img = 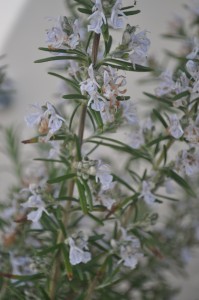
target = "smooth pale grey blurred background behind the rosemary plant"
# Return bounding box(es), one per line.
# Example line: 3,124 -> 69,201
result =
0,0 -> 199,300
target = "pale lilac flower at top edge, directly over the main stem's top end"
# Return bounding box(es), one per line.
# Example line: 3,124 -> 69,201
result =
88,0 -> 106,34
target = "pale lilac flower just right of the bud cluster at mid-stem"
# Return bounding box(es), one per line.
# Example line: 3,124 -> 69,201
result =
95,160 -> 113,190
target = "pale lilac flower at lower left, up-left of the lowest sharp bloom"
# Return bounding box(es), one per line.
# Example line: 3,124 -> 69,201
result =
21,184 -> 48,222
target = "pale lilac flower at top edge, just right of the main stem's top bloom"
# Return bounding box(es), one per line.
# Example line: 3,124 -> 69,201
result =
111,0 -> 126,29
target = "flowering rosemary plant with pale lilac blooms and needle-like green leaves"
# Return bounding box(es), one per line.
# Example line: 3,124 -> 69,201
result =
0,0 -> 199,300
